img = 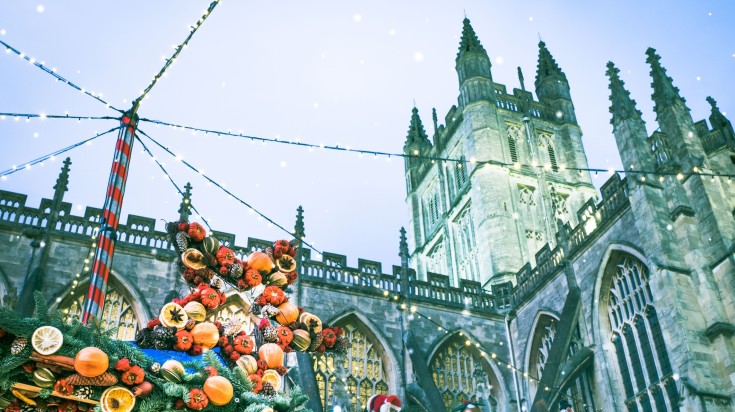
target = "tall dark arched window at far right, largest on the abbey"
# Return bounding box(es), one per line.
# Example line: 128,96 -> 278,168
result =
604,255 -> 679,412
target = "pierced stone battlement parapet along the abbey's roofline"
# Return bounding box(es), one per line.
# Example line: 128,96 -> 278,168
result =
0,174 -> 629,314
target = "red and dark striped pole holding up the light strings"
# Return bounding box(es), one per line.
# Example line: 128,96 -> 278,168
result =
82,112 -> 138,325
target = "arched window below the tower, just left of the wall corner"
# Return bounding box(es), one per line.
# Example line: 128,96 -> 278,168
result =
429,334 -> 501,410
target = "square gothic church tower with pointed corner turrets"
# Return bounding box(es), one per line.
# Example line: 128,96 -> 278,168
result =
404,18 -> 596,287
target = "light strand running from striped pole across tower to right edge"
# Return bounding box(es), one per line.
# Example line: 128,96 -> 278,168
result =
140,118 -> 735,180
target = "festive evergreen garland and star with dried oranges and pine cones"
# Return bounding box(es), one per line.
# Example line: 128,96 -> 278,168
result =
0,217 -> 350,412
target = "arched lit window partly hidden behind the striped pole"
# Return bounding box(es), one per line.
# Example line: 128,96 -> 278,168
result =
59,283 -> 138,340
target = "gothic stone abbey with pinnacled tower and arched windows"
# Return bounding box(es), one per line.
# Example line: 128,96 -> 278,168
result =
0,19 -> 735,412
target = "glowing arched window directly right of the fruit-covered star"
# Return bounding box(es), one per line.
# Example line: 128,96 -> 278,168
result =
312,317 -> 390,411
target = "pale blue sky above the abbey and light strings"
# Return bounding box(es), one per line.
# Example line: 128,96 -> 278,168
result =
0,0 -> 735,271
